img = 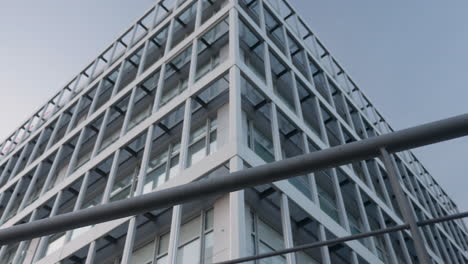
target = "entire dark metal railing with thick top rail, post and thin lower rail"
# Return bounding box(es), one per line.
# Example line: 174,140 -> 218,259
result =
0,114 -> 468,263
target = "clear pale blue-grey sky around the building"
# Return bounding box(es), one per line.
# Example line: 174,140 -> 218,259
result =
0,0 -> 468,210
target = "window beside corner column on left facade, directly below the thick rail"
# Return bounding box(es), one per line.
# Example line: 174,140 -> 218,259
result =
176,209 -> 214,264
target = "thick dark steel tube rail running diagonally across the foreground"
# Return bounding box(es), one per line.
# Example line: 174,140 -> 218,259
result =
0,114 -> 468,245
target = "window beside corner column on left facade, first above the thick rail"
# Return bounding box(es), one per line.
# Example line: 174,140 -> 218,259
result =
187,117 -> 217,167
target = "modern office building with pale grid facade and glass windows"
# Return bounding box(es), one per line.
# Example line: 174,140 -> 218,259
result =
0,0 -> 468,264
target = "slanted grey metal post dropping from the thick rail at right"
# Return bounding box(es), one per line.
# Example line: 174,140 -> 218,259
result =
380,148 -> 431,263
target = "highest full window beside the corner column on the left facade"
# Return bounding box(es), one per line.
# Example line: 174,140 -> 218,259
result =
196,18 -> 229,80
